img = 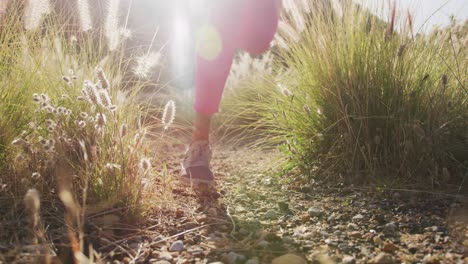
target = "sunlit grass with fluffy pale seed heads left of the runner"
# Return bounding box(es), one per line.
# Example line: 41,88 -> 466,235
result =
0,1 -> 168,250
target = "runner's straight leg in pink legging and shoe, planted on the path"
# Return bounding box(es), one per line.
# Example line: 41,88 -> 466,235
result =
181,0 -> 244,185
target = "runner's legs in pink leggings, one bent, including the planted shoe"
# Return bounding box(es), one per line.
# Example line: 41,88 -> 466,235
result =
182,0 -> 281,184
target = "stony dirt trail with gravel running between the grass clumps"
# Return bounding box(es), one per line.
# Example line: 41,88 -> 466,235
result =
0,146 -> 468,264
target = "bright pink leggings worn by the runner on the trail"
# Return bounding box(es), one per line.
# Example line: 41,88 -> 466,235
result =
194,0 -> 281,115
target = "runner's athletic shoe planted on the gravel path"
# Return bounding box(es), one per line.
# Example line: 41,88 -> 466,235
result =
180,140 -> 214,185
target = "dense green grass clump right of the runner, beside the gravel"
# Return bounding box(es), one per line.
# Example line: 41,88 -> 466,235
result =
225,1 -> 468,188
